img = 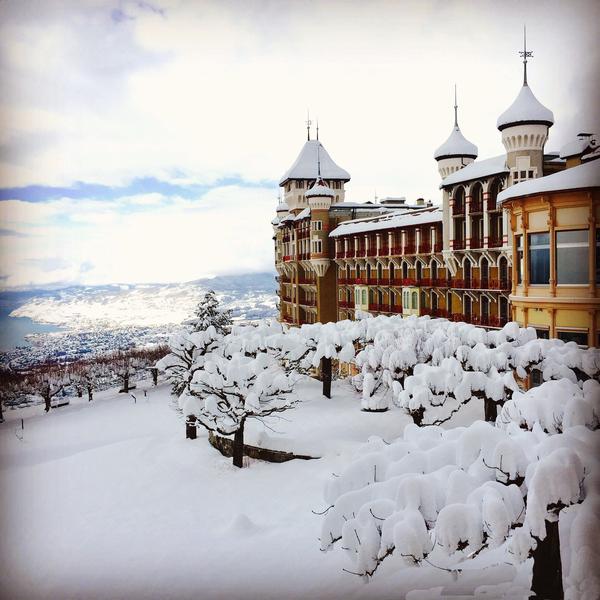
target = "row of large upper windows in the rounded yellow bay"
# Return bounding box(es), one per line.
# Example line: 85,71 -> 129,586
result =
515,229 -> 600,285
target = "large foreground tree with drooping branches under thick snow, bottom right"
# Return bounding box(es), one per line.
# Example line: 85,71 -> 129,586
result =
321,373 -> 600,598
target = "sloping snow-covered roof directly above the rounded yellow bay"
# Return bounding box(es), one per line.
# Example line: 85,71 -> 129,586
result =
498,160 -> 600,204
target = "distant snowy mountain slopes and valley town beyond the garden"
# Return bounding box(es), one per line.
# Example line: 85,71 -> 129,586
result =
0,273 -> 277,368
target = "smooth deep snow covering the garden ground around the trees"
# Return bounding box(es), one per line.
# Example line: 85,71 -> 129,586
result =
0,379 -> 530,600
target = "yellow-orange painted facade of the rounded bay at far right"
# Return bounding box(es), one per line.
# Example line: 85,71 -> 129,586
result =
504,188 -> 600,346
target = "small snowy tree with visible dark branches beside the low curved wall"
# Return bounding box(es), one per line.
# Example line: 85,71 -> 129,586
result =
183,352 -> 298,467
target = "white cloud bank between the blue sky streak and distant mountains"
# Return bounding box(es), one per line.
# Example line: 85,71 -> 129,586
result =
0,185 -> 276,288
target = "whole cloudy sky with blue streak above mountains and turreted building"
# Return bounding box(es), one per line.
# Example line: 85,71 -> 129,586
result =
0,0 -> 600,289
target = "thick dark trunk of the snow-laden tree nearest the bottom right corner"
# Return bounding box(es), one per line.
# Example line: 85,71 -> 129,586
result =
531,520 -> 564,600
